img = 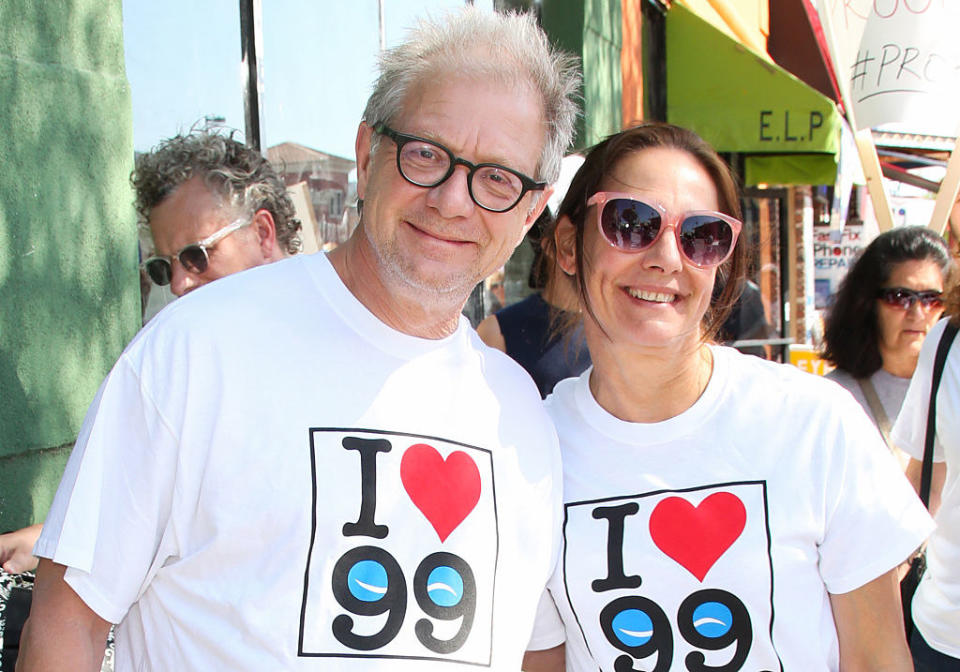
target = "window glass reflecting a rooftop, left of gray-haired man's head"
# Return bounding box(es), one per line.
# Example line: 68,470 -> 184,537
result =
260,0 -> 492,251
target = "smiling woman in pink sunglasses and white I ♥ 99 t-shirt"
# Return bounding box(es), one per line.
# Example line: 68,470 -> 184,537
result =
524,124 -> 931,672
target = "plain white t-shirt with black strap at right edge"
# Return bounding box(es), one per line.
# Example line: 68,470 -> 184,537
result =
893,320 -> 960,658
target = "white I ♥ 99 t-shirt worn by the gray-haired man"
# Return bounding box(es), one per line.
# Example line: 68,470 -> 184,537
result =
36,254 -> 562,672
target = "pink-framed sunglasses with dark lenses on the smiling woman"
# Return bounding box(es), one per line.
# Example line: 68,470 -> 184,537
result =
587,191 -> 743,268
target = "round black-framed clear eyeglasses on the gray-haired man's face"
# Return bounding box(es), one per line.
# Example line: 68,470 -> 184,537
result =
373,122 -> 547,212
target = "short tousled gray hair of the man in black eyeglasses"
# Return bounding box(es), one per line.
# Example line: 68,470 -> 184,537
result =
363,7 -> 580,183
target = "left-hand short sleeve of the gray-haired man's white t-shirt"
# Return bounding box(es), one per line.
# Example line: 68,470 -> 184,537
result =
34,356 -> 176,623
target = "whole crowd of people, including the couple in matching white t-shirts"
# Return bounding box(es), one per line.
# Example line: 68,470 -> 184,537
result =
0,7 -> 960,672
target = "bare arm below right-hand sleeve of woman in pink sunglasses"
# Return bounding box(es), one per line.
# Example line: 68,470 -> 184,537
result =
830,569 -> 913,672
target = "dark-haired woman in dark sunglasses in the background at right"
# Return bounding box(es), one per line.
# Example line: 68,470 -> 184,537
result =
823,226 -> 951,466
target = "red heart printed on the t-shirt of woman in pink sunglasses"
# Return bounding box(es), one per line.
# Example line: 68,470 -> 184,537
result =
650,492 -> 747,582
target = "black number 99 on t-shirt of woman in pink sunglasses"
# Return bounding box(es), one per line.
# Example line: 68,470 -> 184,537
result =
600,589 -> 753,672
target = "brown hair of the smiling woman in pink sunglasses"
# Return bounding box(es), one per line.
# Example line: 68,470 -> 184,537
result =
544,122 -> 747,340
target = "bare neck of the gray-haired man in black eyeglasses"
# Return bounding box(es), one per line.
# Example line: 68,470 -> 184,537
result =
327,238 -> 466,339
